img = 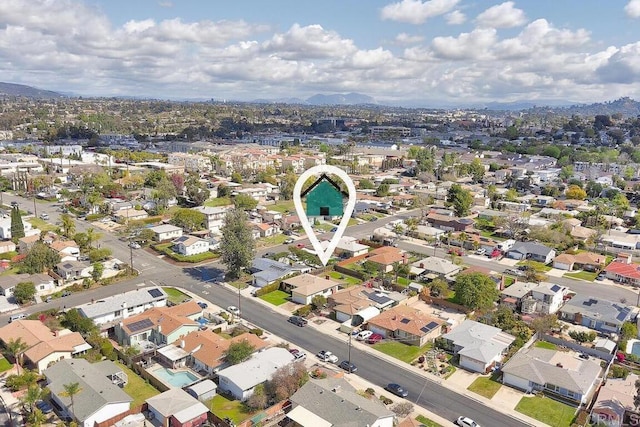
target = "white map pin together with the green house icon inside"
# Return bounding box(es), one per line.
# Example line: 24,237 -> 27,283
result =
293,165 -> 356,265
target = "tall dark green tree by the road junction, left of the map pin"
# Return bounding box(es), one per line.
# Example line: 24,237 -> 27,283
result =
220,209 -> 255,278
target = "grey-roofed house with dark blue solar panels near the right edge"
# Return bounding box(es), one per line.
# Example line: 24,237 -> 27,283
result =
559,294 -> 632,334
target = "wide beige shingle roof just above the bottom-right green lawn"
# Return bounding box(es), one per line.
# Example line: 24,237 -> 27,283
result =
502,347 -> 601,394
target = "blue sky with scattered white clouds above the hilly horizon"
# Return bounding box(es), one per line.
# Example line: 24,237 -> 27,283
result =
0,0 -> 640,107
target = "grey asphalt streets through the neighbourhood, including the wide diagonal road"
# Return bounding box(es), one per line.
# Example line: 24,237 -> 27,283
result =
0,194 -> 637,427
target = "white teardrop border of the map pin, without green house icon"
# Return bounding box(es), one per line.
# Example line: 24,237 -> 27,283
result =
293,165 -> 356,265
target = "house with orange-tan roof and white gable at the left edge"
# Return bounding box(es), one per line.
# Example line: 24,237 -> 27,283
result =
0,319 -> 91,373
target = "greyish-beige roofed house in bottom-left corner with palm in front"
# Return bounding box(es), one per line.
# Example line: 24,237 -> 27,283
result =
43,359 -> 133,427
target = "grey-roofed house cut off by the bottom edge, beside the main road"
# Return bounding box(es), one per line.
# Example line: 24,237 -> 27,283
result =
287,378 -> 395,427
